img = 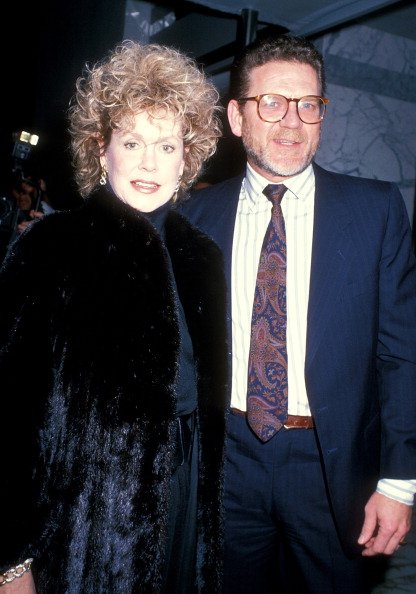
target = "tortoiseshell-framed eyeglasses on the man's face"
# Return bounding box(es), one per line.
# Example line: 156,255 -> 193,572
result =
238,93 -> 329,124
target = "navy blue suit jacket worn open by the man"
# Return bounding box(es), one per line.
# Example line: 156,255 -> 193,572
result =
180,165 -> 416,553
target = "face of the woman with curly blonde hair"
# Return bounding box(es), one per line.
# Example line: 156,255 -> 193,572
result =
101,111 -> 185,212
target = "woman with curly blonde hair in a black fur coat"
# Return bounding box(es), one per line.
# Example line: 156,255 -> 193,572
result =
0,42 -> 226,594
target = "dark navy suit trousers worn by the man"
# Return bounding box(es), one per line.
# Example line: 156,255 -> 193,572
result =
224,412 -> 369,594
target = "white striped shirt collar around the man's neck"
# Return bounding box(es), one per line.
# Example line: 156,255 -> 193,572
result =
243,163 -> 315,206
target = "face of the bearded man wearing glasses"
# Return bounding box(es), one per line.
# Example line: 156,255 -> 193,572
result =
228,61 -> 321,183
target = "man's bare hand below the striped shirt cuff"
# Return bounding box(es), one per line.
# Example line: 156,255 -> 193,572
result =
358,493 -> 412,557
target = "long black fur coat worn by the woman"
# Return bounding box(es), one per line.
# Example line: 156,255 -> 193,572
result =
0,189 -> 226,594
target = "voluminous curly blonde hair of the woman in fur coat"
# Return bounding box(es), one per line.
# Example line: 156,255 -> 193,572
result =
68,40 -> 221,197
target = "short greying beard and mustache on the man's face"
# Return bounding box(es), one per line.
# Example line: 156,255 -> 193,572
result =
242,126 -> 321,177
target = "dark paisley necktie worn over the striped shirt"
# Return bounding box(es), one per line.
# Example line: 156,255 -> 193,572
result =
247,184 -> 287,442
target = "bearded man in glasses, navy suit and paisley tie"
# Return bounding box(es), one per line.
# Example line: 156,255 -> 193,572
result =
183,36 -> 416,594
